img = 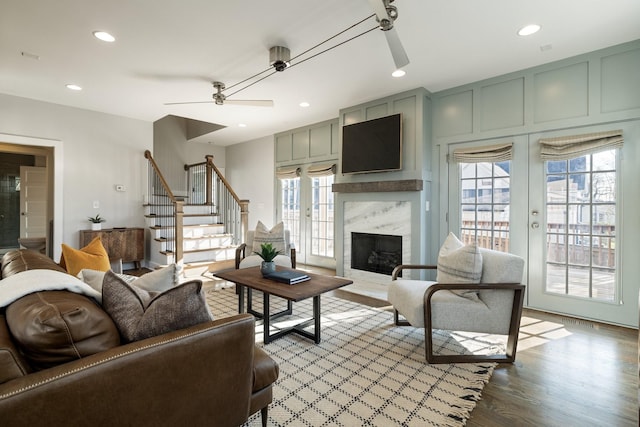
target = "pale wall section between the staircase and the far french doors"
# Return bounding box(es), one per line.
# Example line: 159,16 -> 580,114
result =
225,136 -> 276,229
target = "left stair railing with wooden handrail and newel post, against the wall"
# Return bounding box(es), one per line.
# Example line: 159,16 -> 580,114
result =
144,150 -> 184,264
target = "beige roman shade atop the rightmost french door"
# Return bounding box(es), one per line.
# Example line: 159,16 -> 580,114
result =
538,130 -> 623,160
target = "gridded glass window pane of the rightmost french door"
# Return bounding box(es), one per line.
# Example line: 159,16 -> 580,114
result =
545,149 -> 617,301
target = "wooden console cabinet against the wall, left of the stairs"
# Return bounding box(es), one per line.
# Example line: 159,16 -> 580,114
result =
80,228 -> 144,268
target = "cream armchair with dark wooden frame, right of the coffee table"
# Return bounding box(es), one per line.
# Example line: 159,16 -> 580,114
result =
388,244 -> 525,363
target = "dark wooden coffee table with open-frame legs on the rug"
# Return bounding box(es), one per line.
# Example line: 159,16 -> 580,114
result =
215,267 -> 353,344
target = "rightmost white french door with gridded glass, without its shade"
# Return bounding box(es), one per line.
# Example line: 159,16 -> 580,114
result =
528,128 -> 638,324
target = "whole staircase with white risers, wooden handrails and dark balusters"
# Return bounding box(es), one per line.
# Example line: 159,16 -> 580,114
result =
144,152 -> 248,278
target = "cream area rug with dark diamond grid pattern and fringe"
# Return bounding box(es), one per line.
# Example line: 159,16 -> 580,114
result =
206,288 -> 499,427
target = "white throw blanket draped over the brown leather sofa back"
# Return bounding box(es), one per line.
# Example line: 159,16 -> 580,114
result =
0,269 -> 102,308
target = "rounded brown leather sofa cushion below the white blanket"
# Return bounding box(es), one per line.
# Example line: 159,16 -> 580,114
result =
5,291 -> 120,370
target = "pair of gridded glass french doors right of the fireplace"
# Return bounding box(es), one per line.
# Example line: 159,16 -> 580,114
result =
448,128 -> 638,324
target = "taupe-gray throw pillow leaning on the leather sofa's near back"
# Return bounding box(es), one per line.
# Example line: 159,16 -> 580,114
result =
102,271 -> 213,342
